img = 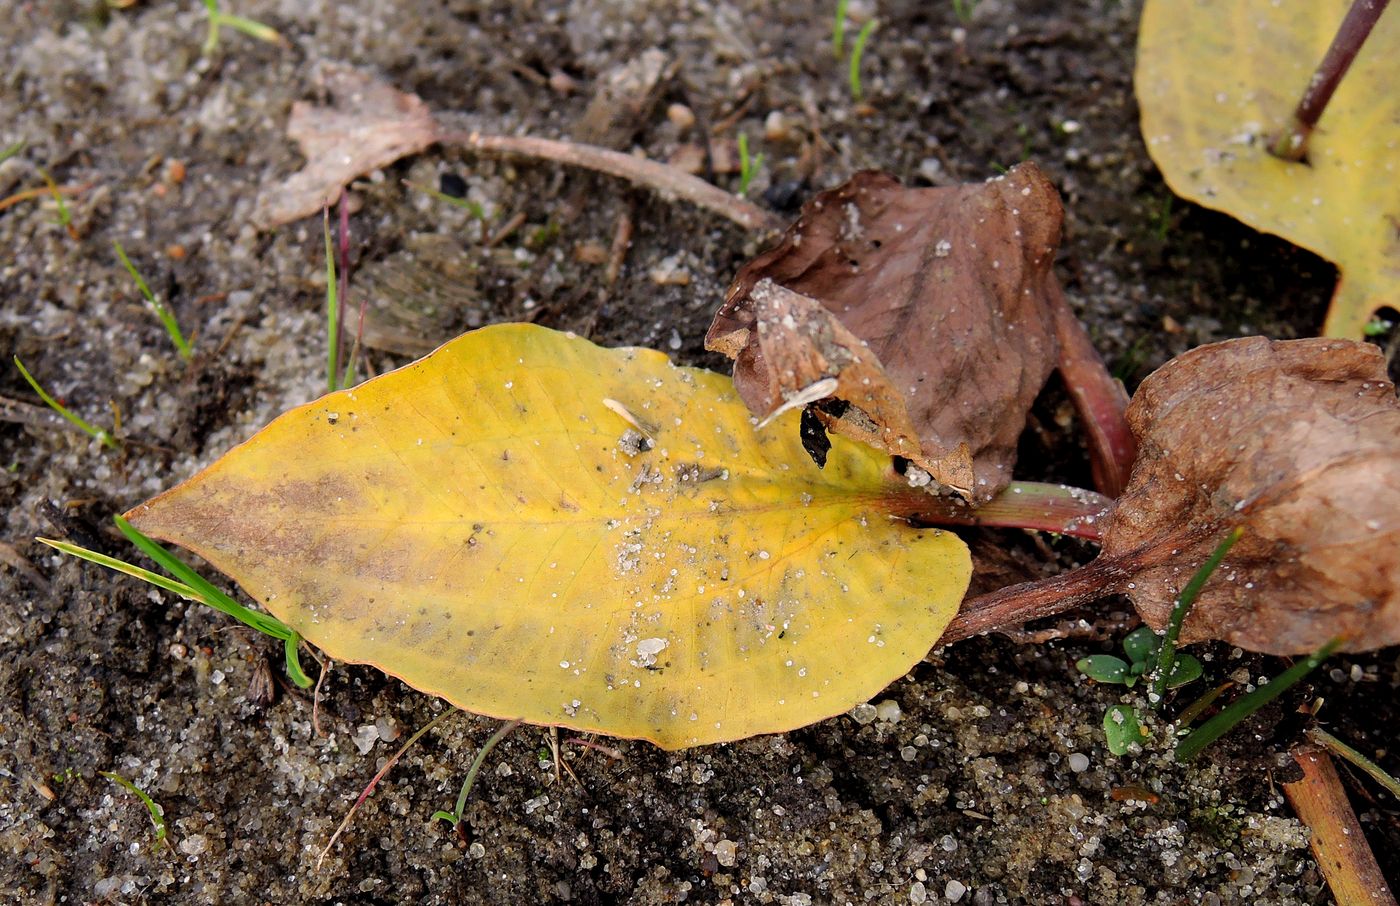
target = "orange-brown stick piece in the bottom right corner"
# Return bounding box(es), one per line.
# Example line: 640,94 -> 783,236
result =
1284,746 -> 1396,906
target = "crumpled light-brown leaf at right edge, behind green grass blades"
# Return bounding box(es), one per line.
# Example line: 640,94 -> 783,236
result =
1103,337 -> 1400,654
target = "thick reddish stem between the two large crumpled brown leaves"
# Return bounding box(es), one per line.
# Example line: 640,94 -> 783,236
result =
1050,287 -> 1137,497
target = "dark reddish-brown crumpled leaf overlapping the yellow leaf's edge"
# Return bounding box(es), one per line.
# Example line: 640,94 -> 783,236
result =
706,164 -> 1063,500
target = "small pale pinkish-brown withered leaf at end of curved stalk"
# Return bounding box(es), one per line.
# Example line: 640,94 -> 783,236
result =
252,64 -> 438,230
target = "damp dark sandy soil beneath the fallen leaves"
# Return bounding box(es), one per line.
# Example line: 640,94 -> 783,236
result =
0,0 -> 1400,905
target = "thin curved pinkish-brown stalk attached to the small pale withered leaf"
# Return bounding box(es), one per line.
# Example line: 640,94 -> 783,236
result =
438,130 -> 783,231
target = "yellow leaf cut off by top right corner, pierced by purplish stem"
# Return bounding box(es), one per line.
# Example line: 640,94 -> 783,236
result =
1135,0 -> 1400,339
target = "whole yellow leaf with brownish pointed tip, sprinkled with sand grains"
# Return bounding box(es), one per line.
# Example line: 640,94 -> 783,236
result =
129,325 -> 970,748
